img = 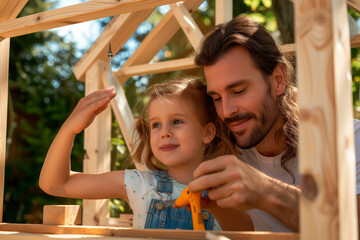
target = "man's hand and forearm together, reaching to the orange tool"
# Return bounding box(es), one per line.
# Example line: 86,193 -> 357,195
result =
189,155 -> 301,231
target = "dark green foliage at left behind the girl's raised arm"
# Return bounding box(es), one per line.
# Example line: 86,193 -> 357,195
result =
3,0 -> 84,223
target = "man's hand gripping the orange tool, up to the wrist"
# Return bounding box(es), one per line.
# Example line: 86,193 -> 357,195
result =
189,155 -> 269,210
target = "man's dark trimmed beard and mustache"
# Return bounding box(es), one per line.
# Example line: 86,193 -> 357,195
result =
224,94 -> 280,149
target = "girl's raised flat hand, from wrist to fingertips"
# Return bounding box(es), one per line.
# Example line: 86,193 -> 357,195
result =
63,87 -> 116,134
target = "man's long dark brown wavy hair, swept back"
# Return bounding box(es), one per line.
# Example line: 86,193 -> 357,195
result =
195,16 -> 299,179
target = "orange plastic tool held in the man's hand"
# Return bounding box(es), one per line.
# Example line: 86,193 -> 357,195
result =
175,187 -> 205,230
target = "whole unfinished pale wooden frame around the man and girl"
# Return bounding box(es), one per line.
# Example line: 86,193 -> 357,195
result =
0,0 -> 360,240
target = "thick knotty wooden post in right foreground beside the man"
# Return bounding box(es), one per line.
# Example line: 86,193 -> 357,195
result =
294,0 -> 358,240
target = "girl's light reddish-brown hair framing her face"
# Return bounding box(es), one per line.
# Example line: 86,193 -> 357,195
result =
133,78 -> 237,170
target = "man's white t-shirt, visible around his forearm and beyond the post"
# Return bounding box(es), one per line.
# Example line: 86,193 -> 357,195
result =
240,120 -> 360,232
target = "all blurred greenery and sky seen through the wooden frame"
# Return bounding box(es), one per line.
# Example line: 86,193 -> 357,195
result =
3,0 -> 360,223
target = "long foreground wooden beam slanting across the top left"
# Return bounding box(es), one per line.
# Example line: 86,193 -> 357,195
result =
0,0 -> 183,38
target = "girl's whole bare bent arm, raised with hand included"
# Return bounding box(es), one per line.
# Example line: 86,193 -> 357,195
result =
39,87 -> 127,200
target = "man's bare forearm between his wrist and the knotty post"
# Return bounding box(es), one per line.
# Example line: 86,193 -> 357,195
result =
261,179 -> 301,232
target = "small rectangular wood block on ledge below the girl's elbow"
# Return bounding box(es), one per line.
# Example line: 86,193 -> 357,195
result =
43,205 -> 81,225
